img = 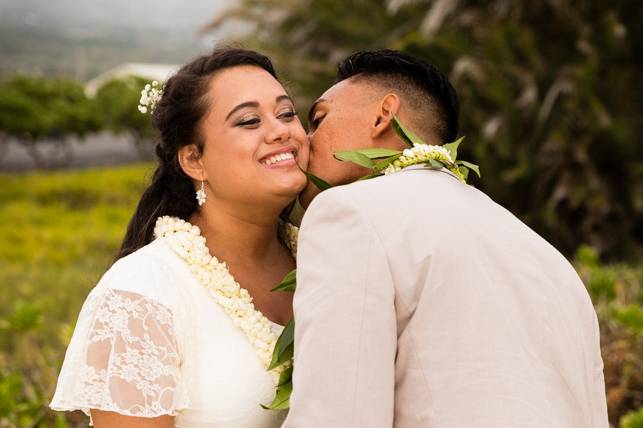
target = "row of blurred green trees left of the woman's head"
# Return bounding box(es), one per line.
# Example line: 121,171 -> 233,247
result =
0,75 -> 156,168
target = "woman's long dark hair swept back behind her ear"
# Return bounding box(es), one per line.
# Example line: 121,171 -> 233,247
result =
116,47 -> 277,259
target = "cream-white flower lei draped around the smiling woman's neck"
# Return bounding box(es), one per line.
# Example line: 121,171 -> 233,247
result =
154,216 -> 298,381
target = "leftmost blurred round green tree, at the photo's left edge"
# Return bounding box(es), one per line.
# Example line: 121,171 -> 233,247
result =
0,75 -> 101,168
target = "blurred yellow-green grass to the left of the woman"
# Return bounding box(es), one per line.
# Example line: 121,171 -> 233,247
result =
0,165 -> 152,428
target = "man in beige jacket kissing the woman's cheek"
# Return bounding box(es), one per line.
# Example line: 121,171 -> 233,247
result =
284,51 -> 608,428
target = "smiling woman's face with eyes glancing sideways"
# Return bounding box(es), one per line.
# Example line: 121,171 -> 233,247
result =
196,65 -> 308,206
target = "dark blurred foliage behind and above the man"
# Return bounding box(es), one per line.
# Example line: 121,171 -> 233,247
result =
204,0 -> 643,260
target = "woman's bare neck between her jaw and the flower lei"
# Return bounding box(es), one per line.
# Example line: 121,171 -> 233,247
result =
190,203 -> 281,262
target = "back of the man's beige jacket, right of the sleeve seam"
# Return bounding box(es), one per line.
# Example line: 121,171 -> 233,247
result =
336,169 -> 607,428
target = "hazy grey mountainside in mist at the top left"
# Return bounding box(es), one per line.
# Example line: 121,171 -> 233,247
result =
0,0 -> 232,80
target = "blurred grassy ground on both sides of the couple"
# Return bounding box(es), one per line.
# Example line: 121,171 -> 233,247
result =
0,165 -> 643,428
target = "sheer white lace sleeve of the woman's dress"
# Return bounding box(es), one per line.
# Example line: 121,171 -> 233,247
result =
51,289 -> 186,417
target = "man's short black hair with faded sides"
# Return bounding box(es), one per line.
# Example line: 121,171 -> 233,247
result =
335,49 -> 460,143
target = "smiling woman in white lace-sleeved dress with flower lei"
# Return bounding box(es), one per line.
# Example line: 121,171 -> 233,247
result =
51,48 -> 308,428
